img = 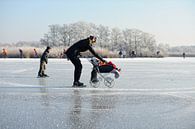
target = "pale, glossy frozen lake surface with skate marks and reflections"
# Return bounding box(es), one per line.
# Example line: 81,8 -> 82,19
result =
0,58 -> 195,129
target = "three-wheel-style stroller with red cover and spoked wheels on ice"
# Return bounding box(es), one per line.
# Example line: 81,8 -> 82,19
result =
88,57 -> 121,88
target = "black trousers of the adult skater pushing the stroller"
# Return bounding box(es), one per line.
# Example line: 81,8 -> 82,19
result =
69,57 -> 82,82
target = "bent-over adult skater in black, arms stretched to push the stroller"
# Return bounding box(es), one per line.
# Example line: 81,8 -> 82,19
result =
66,36 -> 105,87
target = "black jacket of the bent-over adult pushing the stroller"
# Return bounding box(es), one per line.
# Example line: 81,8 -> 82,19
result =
66,38 -> 104,62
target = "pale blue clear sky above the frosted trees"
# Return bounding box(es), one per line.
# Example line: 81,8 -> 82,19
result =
0,0 -> 195,46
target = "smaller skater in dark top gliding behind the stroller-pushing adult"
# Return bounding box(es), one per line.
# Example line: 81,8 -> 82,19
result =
38,46 -> 51,77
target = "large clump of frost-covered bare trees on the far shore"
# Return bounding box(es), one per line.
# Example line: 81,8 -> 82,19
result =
40,22 -> 169,57
